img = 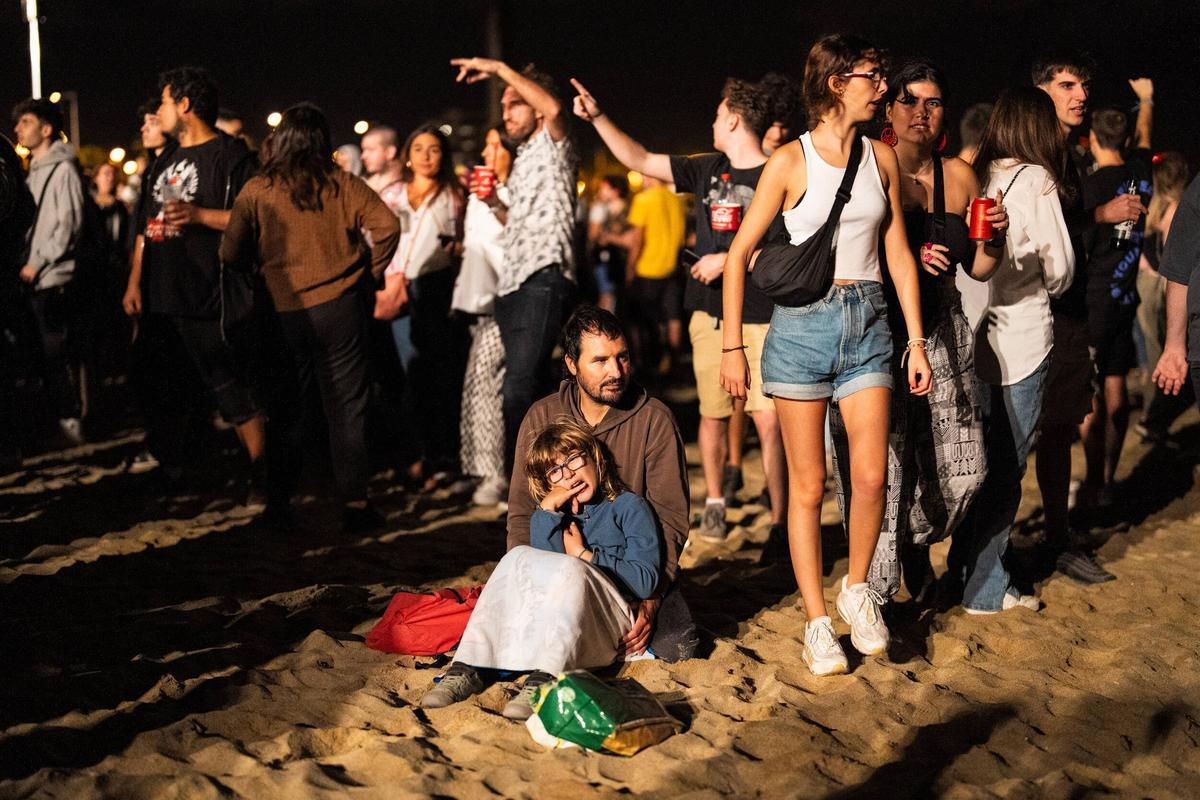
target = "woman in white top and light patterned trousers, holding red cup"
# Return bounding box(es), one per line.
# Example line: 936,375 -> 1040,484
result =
450,126 -> 512,506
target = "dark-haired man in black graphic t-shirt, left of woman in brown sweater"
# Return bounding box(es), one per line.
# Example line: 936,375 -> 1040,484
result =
125,67 -> 265,494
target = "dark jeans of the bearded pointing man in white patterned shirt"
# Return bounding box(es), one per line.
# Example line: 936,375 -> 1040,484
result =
496,265 -> 575,474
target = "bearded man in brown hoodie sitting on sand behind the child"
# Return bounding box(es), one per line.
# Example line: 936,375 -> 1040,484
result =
508,306 -> 697,661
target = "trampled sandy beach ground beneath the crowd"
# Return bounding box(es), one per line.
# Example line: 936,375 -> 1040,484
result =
0,398 -> 1200,800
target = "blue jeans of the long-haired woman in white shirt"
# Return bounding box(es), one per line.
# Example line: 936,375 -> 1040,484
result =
949,357 -> 1050,610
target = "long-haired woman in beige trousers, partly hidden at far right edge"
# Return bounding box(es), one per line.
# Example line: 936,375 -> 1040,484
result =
1134,152 -> 1192,443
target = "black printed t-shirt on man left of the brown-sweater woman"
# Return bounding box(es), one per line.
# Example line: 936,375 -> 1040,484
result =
140,134 -> 253,319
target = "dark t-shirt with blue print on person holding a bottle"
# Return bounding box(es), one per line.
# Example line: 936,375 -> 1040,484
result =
1076,160 -> 1153,308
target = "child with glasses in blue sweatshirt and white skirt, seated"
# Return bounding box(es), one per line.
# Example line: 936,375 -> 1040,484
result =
421,417 -> 662,720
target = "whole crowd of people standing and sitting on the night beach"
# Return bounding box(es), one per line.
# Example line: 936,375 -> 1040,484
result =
0,35 -> 1200,718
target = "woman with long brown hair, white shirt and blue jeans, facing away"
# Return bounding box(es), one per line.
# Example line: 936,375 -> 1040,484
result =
949,86 -> 1080,614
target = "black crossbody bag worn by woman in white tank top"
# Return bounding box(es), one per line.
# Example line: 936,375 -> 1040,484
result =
750,136 -> 863,307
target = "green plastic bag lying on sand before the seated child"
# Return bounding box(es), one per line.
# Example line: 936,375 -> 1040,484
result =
526,669 -> 683,756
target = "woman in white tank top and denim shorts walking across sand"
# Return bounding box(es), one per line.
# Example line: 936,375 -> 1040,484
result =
721,35 -> 931,675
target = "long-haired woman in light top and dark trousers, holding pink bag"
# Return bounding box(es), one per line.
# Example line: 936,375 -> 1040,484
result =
376,125 -> 469,480
